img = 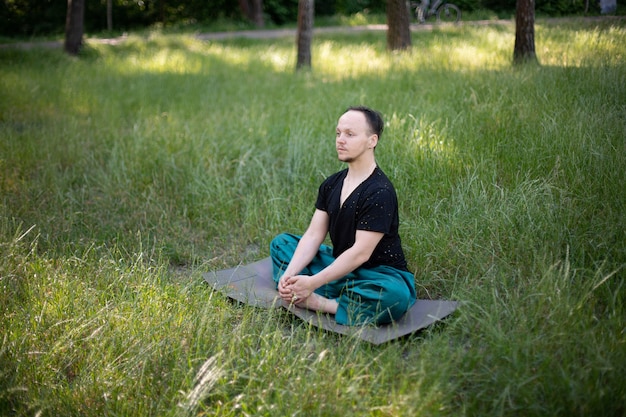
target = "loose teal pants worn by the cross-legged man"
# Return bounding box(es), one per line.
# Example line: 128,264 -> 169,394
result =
270,233 -> 416,326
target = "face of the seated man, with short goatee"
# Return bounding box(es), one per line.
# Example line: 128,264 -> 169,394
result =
335,110 -> 378,162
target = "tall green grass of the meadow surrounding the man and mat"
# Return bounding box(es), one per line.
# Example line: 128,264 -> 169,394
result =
0,17 -> 626,416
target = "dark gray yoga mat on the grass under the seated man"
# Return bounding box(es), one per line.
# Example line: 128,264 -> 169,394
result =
203,257 -> 458,345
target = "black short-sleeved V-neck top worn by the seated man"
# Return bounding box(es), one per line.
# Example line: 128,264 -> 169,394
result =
315,167 -> 407,270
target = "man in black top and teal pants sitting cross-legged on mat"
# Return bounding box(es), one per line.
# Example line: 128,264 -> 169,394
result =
270,107 -> 415,325
